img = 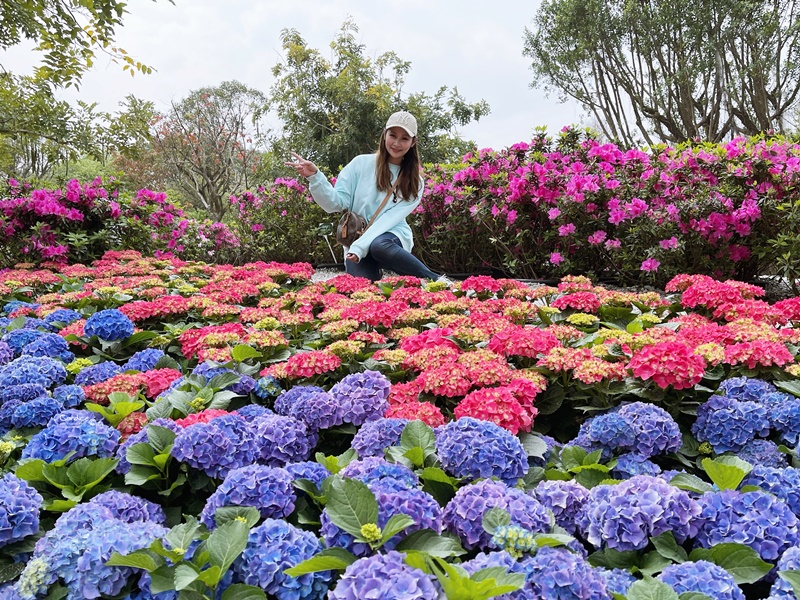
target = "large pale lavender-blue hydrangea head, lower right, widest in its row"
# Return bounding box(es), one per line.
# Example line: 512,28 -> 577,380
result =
580,475 -> 701,552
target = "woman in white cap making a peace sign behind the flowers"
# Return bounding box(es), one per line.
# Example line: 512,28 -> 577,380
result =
285,111 -> 451,284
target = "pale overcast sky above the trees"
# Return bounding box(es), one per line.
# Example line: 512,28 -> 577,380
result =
0,0 -> 582,149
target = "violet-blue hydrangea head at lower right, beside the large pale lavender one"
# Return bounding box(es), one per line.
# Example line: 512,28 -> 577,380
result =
695,490 -> 800,562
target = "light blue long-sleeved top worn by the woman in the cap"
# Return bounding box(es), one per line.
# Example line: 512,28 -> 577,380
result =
308,154 -> 423,260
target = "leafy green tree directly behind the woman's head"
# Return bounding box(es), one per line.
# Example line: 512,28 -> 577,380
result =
268,20 -> 489,172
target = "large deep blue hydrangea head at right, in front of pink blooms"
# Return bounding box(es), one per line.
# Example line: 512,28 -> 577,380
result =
692,395 -> 769,454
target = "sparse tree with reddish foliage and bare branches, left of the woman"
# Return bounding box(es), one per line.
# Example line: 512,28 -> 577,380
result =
153,81 -> 266,221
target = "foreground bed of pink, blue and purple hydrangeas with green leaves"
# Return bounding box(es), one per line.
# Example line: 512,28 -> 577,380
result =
0,251 -> 800,600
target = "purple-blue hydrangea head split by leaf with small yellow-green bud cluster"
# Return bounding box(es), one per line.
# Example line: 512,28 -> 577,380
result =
319,485 -> 442,556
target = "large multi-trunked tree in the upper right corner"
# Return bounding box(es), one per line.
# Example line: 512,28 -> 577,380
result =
524,0 -> 800,145
